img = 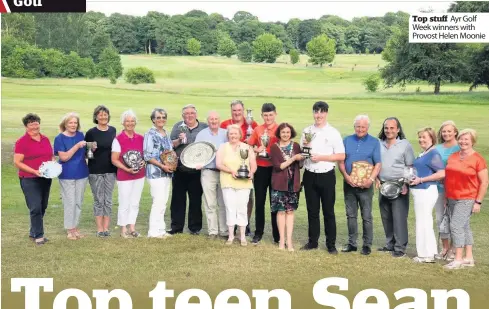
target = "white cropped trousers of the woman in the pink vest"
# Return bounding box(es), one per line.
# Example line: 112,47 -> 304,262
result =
117,178 -> 144,226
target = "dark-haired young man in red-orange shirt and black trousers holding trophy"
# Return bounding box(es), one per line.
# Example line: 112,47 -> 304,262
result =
248,103 -> 280,245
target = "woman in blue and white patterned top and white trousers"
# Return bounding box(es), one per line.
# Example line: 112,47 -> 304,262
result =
143,108 -> 178,238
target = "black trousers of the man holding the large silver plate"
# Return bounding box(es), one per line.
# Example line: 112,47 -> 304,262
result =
170,170 -> 203,232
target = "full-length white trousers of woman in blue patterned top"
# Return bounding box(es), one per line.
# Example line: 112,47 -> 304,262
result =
148,177 -> 171,237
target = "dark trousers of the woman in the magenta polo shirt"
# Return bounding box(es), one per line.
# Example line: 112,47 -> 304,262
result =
20,177 -> 52,238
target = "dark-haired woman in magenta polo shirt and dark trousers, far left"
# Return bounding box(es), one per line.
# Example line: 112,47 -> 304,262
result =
14,113 -> 54,245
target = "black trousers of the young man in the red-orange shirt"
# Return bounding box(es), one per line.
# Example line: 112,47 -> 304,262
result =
253,166 -> 280,242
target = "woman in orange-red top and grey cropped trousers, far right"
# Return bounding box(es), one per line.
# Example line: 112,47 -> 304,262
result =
445,129 -> 489,269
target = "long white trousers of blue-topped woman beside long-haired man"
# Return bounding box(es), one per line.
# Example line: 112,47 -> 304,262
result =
411,185 -> 438,258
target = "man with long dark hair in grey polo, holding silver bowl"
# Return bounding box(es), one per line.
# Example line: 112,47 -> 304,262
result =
376,117 -> 414,257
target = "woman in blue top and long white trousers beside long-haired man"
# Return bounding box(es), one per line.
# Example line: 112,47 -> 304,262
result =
411,128 -> 445,263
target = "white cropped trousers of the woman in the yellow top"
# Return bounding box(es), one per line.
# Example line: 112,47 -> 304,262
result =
222,188 -> 251,226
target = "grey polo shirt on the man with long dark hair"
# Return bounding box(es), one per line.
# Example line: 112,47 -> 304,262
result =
379,138 -> 414,181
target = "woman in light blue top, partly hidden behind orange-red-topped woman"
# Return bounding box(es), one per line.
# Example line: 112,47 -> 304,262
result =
435,120 -> 460,261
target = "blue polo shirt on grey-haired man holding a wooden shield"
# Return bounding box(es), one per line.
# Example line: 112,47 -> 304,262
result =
343,134 -> 381,175
